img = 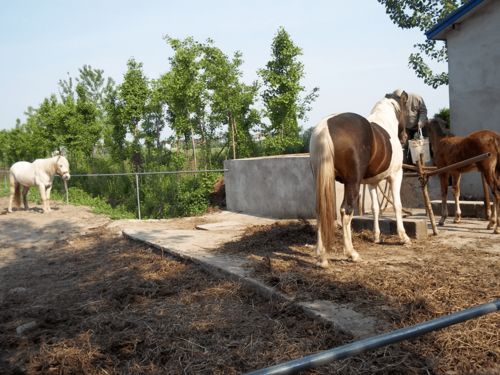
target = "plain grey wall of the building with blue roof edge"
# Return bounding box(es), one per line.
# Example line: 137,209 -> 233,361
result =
446,0 -> 500,198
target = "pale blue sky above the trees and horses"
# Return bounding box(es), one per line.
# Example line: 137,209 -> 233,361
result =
0,0 -> 449,129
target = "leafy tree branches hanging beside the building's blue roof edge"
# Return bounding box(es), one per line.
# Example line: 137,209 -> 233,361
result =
377,0 -> 465,88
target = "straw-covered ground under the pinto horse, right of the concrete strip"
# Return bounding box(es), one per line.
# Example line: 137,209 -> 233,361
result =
223,222 -> 500,374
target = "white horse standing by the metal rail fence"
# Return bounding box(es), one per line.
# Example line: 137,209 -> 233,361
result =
8,155 -> 71,212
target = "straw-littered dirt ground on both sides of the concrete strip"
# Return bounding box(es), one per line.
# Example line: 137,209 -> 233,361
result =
0,199 -> 500,374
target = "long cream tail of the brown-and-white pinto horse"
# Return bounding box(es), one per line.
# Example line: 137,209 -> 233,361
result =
309,120 -> 336,251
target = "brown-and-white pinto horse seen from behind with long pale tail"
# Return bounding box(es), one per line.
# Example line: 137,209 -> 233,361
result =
310,92 -> 411,267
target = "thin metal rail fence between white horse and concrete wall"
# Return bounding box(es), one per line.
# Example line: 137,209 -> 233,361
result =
0,169 -> 228,220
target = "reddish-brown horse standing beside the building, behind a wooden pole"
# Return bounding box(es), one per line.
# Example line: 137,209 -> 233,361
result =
425,119 -> 500,233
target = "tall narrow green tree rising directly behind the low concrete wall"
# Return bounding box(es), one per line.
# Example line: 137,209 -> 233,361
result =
259,27 -> 319,153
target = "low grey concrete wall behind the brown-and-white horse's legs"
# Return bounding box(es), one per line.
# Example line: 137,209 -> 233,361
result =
224,154 -> 438,219
